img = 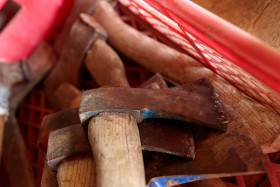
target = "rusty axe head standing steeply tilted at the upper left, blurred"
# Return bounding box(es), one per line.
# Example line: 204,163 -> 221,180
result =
44,19 -> 99,104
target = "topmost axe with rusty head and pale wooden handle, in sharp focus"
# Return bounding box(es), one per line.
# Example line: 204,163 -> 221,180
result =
79,79 -> 228,186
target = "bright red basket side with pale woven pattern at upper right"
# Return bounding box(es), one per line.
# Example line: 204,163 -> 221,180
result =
119,0 -> 280,112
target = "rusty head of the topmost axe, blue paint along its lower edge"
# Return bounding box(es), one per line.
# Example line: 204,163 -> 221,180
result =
79,79 -> 228,131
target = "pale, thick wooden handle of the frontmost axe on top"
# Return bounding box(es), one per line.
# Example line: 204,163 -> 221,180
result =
88,112 -> 145,187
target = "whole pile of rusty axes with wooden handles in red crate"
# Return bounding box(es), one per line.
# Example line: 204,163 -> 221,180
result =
0,1 -> 277,187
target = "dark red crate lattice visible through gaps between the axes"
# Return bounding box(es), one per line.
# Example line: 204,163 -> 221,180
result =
0,1 -> 280,187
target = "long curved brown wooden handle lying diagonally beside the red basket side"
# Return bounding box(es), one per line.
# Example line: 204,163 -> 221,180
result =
93,1 -> 212,82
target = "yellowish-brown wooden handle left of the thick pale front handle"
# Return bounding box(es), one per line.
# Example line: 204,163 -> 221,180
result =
57,155 -> 96,187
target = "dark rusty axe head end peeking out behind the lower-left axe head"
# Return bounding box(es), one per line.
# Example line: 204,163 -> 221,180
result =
38,108 -> 80,150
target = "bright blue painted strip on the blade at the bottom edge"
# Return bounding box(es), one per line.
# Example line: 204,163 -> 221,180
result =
147,175 -> 205,187
